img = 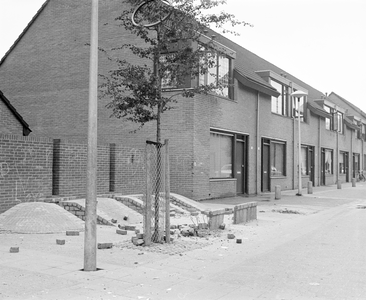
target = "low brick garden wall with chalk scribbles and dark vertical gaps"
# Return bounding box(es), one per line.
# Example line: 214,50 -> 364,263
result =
0,134 -> 145,213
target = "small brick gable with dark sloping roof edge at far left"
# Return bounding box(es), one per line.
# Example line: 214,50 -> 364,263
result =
0,91 -> 32,136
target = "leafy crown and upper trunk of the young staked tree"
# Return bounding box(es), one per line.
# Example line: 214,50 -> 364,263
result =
100,0 -> 249,143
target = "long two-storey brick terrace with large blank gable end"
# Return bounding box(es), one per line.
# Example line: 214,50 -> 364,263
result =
0,0 -> 366,200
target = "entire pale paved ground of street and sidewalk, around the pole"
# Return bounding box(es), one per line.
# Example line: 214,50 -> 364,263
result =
0,182 -> 366,300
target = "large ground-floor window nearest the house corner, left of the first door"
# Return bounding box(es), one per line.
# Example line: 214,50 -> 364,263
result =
210,132 -> 234,178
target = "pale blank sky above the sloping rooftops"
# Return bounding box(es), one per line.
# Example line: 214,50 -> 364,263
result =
0,0 -> 366,112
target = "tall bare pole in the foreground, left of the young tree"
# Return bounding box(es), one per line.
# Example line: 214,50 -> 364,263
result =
84,0 -> 98,271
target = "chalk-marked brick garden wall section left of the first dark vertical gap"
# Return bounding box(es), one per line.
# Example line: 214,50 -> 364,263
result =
0,134 -> 52,213
